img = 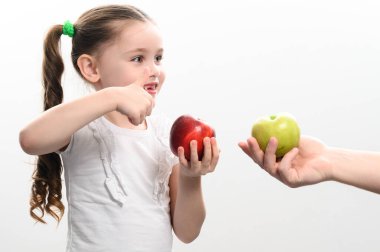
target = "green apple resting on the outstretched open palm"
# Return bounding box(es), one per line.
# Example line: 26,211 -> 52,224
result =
251,113 -> 300,158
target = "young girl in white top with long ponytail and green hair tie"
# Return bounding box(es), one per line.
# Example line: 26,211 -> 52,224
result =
20,5 -> 219,252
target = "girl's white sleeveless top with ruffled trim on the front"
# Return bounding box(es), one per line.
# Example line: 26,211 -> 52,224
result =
61,116 -> 178,252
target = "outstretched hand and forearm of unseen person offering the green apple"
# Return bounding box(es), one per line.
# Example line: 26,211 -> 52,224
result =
239,137 -> 380,194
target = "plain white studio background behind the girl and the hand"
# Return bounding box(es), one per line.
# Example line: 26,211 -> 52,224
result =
0,0 -> 380,252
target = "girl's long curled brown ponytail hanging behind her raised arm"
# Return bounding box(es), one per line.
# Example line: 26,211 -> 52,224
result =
30,25 -> 65,223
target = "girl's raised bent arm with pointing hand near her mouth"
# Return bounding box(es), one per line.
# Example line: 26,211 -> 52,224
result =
19,80 -> 154,155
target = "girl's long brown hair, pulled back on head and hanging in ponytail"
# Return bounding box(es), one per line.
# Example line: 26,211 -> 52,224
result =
30,5 -> 152,223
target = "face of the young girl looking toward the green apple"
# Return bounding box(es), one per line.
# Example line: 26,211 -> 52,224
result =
97,21 -> 165,96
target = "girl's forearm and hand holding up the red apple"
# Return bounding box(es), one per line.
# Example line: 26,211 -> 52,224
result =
170,138 -> 219,243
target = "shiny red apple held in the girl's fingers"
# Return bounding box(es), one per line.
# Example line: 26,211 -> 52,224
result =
170,115 -> 215,160
